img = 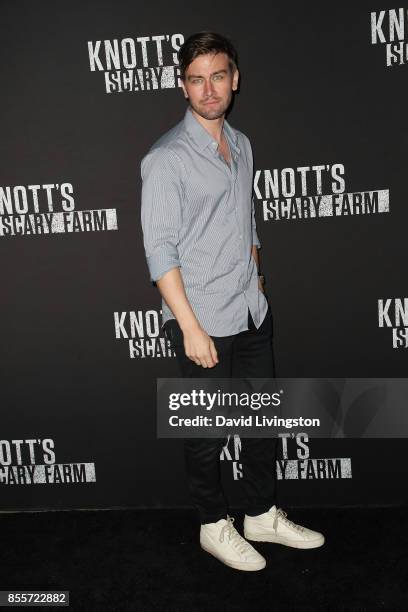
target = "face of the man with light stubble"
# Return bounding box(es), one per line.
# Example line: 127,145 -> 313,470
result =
181,53 -> 239,119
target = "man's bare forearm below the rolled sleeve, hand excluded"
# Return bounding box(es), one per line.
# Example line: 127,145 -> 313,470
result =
156,268 -> 201,332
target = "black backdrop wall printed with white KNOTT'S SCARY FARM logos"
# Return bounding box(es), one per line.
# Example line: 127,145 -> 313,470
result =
0,0 -> 408,510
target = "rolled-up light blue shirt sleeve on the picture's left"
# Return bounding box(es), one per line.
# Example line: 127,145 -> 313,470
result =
140,147 -> 183,281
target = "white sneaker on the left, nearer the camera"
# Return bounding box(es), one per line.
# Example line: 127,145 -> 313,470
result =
200,514 -> 266,572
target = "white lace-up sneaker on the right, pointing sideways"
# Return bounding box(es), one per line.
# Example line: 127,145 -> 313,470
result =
244,506 -> 324,548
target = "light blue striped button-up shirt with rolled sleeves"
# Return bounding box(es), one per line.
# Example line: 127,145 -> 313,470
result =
141,106 -> 268,336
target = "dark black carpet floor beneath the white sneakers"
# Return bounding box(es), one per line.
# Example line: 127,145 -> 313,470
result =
0,508 -> 408,612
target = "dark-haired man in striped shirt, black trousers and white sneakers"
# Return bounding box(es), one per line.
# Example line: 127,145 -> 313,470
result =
141,32 -> 324,571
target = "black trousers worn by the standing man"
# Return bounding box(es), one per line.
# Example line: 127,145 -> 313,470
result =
164,306 -> 277,524
